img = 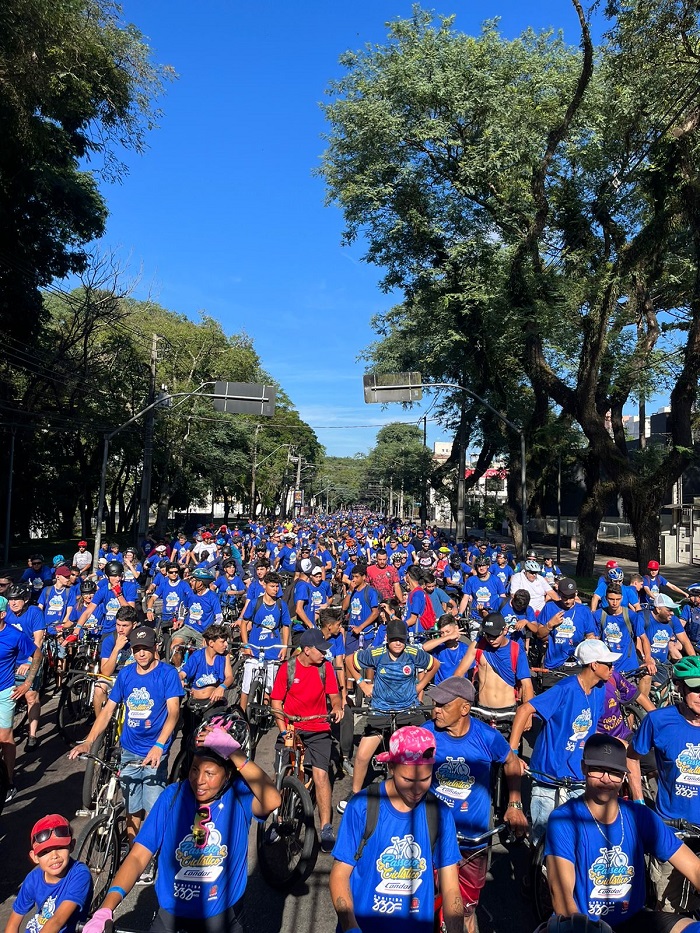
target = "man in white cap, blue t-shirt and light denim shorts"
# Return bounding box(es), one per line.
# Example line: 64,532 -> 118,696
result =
510,638 -> 620,843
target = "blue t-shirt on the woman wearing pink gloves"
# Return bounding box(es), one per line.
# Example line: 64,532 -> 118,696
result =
136,777 -> 253,919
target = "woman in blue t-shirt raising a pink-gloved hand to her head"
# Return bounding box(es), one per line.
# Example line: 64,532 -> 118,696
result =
83,716 -> 282,933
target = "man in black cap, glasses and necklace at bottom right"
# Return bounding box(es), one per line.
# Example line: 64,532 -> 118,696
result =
545,733 -> 700,933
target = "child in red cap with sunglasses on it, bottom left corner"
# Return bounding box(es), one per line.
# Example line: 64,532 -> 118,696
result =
5,813 -> 92,933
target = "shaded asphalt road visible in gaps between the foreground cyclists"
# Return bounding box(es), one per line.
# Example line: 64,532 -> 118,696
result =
0,698 -> 536,933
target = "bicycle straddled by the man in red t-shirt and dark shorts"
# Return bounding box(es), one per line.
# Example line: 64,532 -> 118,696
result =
256,713 -> 329,889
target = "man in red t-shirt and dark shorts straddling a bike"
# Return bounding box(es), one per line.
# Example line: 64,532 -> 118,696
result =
270,628 -> 343,852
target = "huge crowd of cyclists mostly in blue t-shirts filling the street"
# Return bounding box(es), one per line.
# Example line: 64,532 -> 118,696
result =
0,511 -> 700,933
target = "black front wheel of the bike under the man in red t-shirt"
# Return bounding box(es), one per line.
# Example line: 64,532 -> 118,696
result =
257,775 -> 318,888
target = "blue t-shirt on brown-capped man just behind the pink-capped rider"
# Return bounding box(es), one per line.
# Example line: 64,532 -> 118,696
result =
424,716 -> 510,836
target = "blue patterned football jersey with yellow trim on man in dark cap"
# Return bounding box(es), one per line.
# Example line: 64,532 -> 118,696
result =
355,645 -> 435,712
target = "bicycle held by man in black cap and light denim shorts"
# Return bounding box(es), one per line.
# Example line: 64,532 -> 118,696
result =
74,753 -> 129,913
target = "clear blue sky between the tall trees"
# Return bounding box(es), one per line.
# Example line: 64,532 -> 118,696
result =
90,0 -> 578,456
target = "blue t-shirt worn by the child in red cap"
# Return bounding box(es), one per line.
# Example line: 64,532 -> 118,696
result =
12,859 -> 92,933
